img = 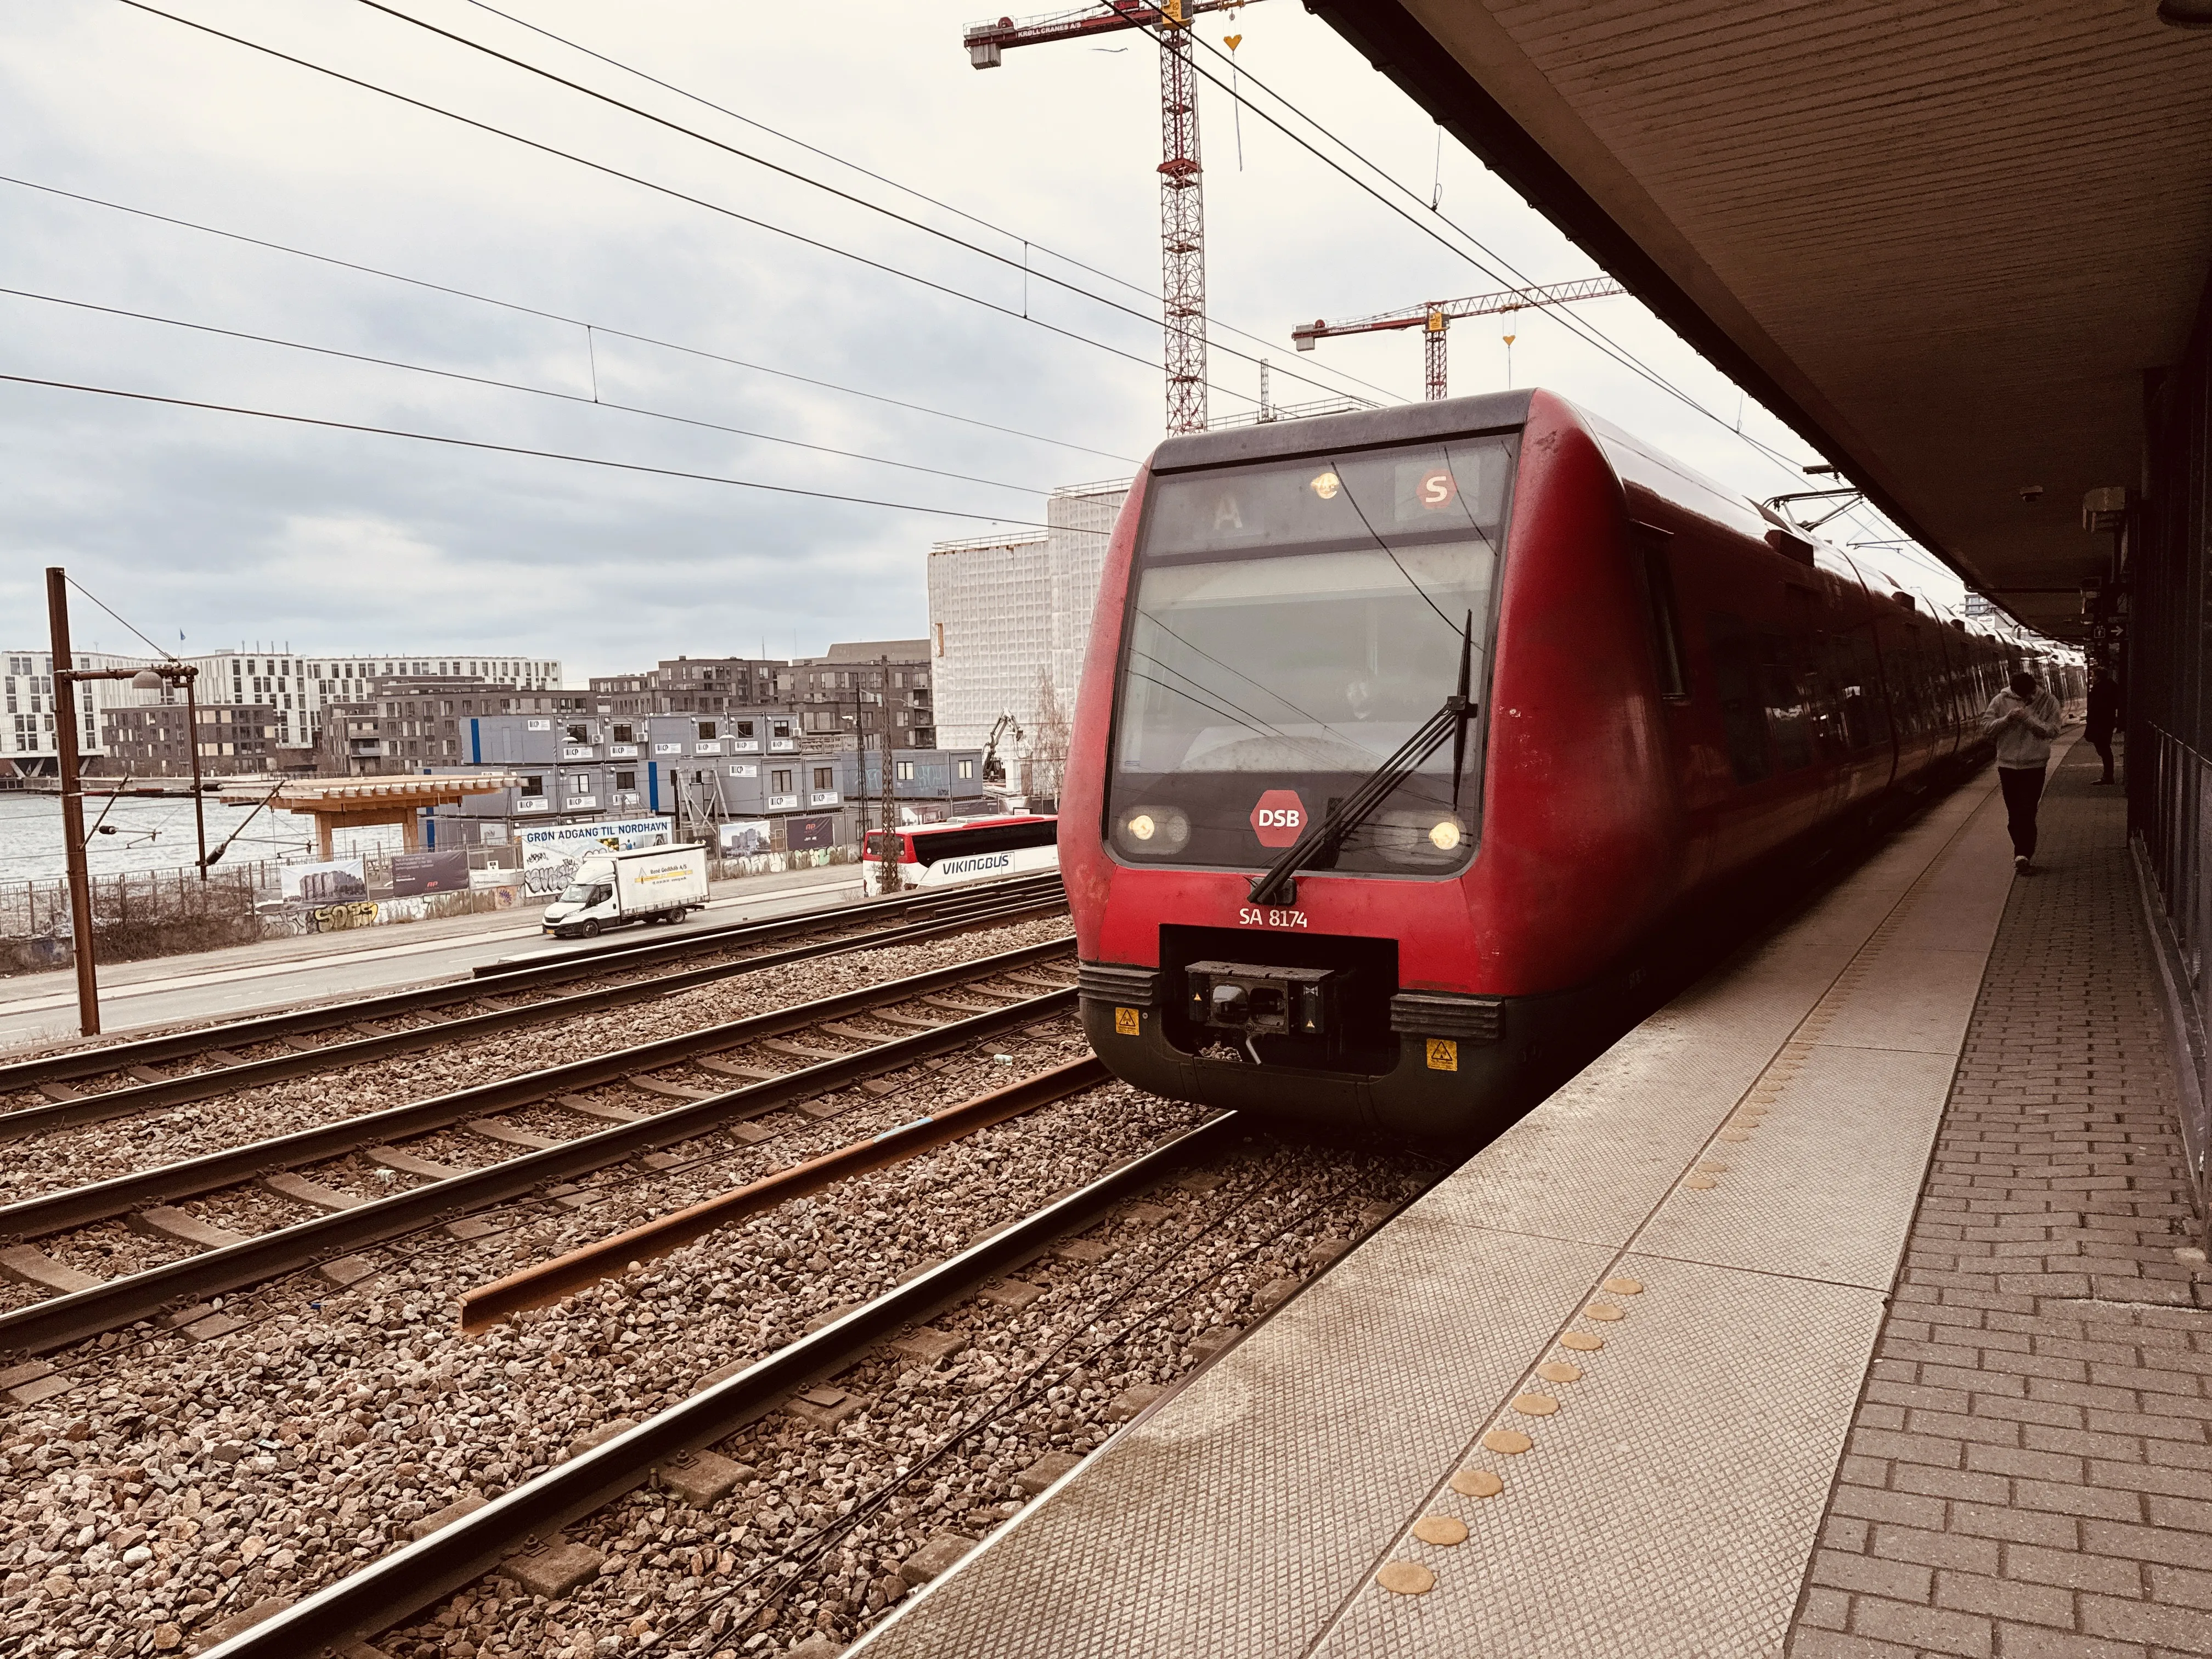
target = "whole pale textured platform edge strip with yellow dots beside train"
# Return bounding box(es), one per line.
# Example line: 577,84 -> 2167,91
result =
860,787 -> 2011,1659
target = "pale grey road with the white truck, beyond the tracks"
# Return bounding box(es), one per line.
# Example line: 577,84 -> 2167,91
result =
0,867 -> 860,1053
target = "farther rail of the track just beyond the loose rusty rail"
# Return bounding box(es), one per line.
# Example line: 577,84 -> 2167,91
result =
0,938 -> 1075,1241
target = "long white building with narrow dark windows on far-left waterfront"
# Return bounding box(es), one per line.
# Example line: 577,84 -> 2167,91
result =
0,648 -> 560,772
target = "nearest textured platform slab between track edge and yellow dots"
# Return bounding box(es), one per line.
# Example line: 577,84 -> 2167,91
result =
870,1215 -> 1612,1659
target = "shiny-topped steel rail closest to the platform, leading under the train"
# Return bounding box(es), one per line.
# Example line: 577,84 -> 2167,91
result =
204,1113 -> 1239,1659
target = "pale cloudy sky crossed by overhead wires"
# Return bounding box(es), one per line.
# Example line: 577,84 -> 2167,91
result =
0,0 -> 1957,684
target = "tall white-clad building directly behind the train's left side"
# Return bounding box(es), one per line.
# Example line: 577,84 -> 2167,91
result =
929,480 -> 1128,789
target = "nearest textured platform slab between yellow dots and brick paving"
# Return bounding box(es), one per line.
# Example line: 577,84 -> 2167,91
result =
1318,1256 -> 1882,1659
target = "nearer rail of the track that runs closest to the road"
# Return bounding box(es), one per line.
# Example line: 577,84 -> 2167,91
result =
0,898 -> 1066,1141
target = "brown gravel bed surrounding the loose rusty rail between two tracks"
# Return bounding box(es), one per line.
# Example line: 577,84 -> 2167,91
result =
0,1053 -> 1265,1659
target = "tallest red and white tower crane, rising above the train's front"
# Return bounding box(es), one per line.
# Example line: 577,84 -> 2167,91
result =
962,0 -> 1248,433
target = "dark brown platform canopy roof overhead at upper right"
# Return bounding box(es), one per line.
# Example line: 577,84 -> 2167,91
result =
1310,0 -> 2212,637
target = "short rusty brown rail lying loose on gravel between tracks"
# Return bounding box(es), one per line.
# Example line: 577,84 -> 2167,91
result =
460,1055 -> 1113,1334
